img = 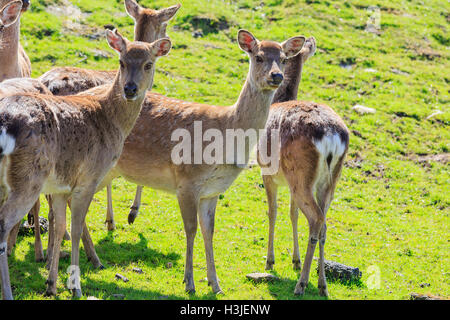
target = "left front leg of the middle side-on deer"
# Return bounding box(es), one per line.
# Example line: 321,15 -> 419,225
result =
177,188 -> 197,293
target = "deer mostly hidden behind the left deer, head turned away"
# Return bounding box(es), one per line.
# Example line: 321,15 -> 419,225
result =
39,0 -> 181,96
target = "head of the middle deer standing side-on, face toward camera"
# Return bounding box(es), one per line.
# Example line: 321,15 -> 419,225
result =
238,30 -> 305,90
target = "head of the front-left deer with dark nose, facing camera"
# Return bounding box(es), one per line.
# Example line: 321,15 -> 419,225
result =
106,30 -> 172,101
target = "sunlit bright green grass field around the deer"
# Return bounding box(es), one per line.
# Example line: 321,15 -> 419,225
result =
5,0 -> 450,299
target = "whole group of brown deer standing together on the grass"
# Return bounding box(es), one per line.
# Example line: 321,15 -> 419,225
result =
0,0 -> 349,299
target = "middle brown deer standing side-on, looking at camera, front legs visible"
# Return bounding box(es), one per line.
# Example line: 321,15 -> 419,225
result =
75,30 -> 305,293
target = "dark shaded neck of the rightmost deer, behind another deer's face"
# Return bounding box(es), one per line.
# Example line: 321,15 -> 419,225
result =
273,54 -> 303,103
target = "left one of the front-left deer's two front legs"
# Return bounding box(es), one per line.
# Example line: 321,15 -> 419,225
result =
45,194 -> 67,296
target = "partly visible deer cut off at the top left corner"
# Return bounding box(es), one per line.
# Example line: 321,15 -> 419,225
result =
0,0 -> 31,82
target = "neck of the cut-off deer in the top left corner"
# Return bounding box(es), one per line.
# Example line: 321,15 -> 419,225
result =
0,20 -> 22,82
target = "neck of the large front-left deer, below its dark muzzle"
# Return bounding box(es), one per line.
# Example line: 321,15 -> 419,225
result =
101,71 -> 151,137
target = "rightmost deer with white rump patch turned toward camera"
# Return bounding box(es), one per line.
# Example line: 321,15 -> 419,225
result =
258,38 -> 349,296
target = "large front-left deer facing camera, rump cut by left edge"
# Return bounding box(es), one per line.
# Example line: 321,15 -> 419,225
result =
0,30 -> 171,299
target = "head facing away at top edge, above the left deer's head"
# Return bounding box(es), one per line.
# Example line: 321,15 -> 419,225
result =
125,0 -> 181,42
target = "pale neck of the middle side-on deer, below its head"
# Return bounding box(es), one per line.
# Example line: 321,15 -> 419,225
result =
231,76 -> 274,130
